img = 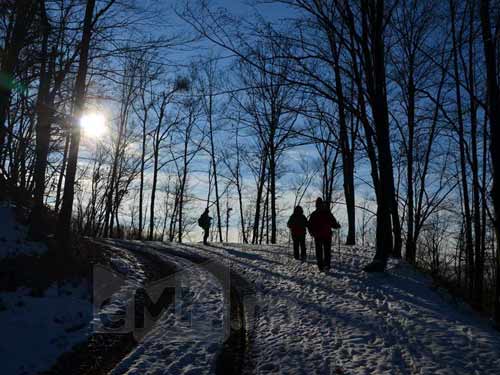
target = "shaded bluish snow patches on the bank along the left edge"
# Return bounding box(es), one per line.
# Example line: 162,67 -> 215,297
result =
0,201 -> 92,375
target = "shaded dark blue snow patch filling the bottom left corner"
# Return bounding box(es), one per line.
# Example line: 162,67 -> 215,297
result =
0,285 -> 92,375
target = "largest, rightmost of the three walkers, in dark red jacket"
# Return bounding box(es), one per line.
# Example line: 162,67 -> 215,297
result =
307,198 -> 340,272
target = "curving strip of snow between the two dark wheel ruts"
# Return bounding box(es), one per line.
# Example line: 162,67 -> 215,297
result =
107,241 -> 226,375
